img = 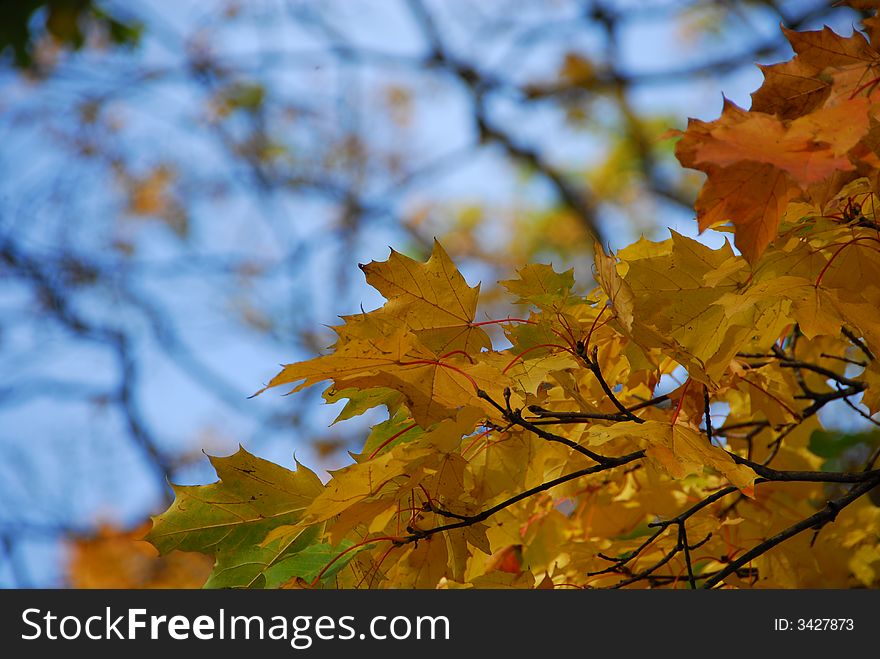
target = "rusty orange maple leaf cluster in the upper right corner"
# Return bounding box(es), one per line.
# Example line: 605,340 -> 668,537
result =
676,21 -> 880,263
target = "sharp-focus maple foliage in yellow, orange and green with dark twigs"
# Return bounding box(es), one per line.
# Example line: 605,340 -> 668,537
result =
148,9 -> 880,588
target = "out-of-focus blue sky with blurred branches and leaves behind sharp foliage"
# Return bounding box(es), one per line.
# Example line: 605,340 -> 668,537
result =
0,0 -> 859,587
